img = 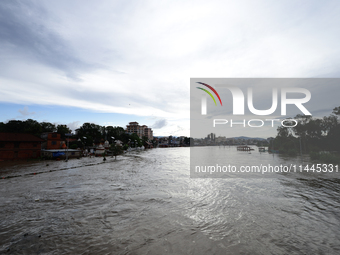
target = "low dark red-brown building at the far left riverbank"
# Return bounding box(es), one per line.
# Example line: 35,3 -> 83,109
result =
0,133 -> 44,160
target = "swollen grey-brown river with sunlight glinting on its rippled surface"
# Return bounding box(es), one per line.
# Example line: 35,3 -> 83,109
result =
0,147 -> 340,254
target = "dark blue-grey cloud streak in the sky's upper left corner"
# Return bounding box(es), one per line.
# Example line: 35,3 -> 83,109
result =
0,1 -> 91,80
